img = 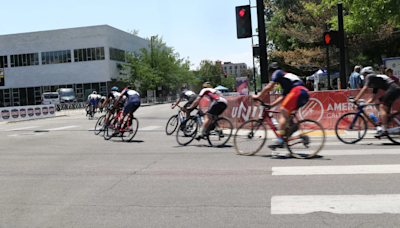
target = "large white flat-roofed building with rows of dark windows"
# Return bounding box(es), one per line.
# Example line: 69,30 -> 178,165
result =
0,25 -> 150,106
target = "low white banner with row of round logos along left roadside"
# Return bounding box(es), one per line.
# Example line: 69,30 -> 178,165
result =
0,104 -> 56,121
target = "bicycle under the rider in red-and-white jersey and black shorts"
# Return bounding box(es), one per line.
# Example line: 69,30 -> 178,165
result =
176,108 -> 233,147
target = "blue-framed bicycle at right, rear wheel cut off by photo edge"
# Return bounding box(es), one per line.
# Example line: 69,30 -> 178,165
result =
335,96 -> 400,144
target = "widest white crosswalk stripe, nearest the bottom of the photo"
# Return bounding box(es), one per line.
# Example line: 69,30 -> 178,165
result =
271,194 -> 400,214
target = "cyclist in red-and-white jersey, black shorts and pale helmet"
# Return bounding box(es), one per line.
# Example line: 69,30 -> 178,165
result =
187,82 -> 228,140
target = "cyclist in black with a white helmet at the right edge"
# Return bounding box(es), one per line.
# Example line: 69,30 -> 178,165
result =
354,66 -> 400,139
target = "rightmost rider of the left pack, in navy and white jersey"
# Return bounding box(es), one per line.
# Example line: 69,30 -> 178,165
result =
114,86 -> 140,133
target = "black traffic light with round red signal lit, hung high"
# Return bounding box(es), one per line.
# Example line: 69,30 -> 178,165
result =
236,5 -> 253,39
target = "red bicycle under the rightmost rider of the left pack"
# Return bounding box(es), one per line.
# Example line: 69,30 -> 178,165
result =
104,110 -> 139,142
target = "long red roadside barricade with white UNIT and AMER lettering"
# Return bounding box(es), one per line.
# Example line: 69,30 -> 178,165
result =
199,90 -> 400,129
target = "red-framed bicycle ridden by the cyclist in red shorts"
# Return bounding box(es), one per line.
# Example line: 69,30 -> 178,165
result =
233,99 -> 325,158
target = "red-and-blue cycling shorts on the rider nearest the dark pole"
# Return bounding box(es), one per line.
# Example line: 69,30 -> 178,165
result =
281,86 -> 309,113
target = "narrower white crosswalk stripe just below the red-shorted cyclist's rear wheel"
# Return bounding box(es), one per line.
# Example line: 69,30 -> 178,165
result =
272,164 -> 400,176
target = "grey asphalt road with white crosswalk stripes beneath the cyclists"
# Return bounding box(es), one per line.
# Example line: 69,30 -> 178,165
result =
0,105 -> 400,228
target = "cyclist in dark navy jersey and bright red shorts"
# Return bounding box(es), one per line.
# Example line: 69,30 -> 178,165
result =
253,62 -> 309,150
